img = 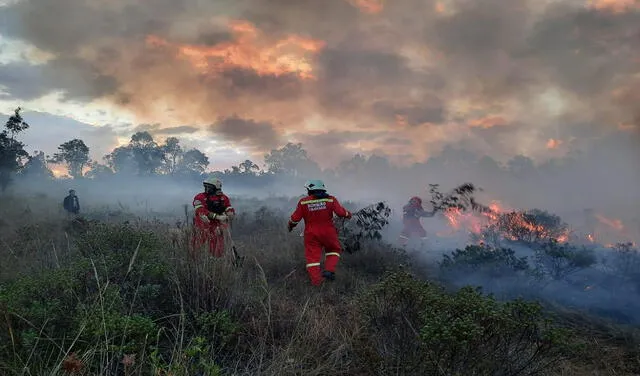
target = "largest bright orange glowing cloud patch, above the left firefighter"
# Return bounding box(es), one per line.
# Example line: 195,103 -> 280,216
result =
146,21 -> 325,79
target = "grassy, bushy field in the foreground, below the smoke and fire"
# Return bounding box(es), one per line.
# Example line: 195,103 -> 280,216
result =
0,192 -> 640,376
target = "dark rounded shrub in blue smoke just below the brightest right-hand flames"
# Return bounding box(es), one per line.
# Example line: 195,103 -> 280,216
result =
535,239 -> 597,280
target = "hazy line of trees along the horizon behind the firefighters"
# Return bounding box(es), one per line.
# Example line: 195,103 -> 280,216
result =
0,108 -> 620,200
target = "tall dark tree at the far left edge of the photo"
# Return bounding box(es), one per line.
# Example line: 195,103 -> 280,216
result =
0,107 -> 29,192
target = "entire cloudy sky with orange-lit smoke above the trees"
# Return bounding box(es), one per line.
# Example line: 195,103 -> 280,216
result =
0,0 -> 640,168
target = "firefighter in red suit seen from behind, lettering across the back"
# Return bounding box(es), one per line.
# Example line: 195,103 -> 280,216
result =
288,180 -> 351,286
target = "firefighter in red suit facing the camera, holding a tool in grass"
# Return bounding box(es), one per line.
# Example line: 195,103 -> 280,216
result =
192,178 -> 235,257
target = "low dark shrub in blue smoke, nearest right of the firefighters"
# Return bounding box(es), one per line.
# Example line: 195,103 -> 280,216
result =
440,245 -> 529,277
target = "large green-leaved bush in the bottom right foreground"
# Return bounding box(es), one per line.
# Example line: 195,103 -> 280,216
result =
359,272 -> 571,375
